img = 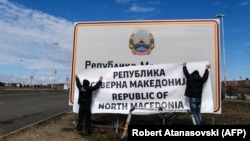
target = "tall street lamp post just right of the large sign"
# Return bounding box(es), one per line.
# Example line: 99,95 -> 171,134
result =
216,14 -> 227,94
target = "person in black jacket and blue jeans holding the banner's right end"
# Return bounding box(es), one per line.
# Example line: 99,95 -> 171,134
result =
183,62 -> 211,125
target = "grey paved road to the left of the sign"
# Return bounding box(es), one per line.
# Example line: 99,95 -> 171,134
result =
0,90 -> 72,136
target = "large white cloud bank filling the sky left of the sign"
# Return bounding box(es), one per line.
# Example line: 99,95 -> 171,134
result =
0,0 -> 74,81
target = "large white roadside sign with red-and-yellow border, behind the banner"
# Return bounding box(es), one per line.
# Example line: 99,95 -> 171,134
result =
69,19 -> 221,114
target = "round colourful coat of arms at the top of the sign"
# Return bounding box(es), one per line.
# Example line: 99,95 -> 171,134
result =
129,28 -> 155,55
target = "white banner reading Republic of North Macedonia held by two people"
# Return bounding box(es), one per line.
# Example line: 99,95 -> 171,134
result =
73,62 -> 214,114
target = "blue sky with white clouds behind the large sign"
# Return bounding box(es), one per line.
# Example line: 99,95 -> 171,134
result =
0,0 -> 250,84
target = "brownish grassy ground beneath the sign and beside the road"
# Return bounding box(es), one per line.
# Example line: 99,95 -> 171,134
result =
0,100 -> 250,141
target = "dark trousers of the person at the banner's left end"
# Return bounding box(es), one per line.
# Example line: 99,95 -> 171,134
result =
77,105 -> 91,133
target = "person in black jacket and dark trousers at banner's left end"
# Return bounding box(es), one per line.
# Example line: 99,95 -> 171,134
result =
76,75 -> 103,135
